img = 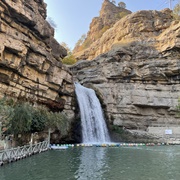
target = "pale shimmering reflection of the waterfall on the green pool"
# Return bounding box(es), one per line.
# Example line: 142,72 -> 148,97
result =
75,147 -> 108,180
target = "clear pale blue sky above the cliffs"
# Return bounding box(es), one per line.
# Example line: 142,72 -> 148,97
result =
44,0 -> 178,50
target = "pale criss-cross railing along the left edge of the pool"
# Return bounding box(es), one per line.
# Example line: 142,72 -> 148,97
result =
0,141 -> 49,166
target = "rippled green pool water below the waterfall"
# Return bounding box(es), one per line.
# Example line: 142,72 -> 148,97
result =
0,146 -> 180,180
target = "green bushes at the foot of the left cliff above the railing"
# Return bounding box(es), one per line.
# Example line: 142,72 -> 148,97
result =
0,98 -> 68,142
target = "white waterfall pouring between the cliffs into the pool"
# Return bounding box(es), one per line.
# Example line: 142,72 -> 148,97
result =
75,83 -> 110,143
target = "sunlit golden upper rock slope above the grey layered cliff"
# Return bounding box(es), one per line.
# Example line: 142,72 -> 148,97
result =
75,9 -> 173,60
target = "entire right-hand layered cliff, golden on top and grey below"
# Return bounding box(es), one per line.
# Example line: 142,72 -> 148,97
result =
71,9 -> 180,142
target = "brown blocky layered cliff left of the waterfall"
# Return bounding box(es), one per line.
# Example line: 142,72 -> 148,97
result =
0,0 -> 74,117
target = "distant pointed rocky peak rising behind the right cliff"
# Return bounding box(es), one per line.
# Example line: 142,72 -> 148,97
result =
73,0 -> 131,53
